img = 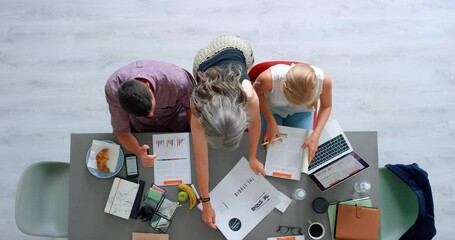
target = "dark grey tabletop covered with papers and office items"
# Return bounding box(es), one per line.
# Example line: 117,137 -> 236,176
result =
68,132 -> 379,240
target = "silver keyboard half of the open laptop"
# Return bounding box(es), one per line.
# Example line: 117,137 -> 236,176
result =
302,120 -> 353,175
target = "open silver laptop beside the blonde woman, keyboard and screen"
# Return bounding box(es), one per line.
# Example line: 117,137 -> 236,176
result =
302,120 -> 369,191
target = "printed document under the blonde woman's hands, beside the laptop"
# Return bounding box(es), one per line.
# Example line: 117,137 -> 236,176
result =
265,126 -> 311,181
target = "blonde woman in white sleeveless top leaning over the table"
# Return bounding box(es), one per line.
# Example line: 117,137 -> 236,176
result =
253,63 -> 332,162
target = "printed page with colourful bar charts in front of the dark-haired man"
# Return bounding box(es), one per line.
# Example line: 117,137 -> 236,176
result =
153,133 -> 191,186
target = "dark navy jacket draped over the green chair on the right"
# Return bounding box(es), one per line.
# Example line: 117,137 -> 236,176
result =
385,163 -> 436,240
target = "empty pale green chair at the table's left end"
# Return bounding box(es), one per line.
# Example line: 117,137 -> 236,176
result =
15,162 -> 70,237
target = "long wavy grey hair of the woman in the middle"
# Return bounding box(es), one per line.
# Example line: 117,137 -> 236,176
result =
191,66 -> 249,150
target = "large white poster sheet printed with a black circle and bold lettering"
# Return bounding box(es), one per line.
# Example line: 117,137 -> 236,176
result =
210,158 -> 280,240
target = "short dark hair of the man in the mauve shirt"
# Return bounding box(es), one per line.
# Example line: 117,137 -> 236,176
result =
117,79 -> 152,117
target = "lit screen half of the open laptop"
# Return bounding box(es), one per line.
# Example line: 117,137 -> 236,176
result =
310,152 -> 369,191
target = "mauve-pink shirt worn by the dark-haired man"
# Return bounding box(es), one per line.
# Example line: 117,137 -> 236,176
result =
105,60 -> 194,132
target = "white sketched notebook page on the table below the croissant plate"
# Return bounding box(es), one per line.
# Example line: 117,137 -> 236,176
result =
104,177 -> 139,220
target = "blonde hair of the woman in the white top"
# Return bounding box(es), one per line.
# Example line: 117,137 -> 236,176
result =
283,63 -> 321,106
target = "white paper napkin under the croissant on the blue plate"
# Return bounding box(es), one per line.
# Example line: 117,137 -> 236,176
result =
87,140 -> 120,173
